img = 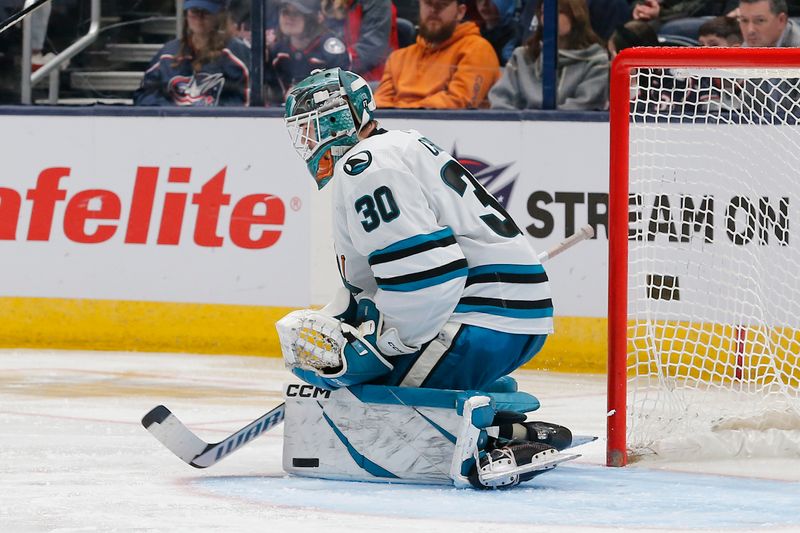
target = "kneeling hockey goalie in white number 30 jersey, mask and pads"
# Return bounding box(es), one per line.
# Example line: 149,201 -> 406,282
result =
277,69 -> 576,489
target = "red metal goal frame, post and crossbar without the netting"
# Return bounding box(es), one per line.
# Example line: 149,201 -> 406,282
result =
606,47 -> 800,466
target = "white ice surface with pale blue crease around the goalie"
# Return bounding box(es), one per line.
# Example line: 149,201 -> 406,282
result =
0,350 -> 800,533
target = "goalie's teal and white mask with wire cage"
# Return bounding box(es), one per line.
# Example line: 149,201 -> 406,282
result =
285,68 -> 375,189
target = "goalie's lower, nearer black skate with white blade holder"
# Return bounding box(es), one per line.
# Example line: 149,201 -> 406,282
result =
469,442 -> 580,489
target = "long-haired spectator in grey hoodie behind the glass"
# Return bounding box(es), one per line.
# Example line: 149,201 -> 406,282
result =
489,0 -> 609,110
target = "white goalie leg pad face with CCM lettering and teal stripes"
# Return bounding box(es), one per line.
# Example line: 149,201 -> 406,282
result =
283,384 -> 461,484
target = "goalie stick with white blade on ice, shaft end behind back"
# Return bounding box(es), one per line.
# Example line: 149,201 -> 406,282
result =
142,224 -> 594,468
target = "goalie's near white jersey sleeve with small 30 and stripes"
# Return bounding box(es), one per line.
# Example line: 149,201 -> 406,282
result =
334,137 -> 467,348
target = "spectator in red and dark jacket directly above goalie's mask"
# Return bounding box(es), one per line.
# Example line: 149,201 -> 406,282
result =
322,0 -> 398,83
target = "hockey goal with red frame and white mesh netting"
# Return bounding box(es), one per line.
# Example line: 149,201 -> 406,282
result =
608,48 -> 800,466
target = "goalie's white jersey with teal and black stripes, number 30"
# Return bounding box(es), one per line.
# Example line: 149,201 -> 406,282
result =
331,130 -> 553,349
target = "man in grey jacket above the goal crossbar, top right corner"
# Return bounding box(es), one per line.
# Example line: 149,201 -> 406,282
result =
739,0 -> 800,47
